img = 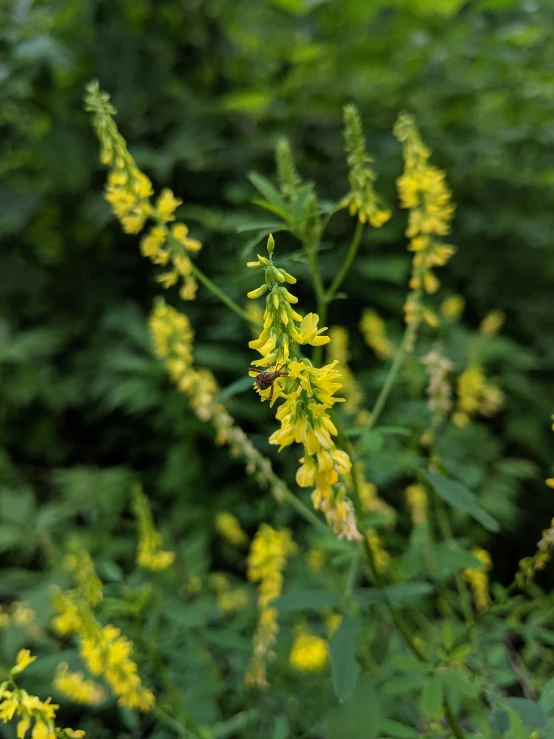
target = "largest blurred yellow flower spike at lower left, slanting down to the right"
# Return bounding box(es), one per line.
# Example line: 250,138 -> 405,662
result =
52,553 -> 155,711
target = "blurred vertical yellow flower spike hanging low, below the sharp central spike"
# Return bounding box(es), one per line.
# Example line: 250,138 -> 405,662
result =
246,523 -> 296,688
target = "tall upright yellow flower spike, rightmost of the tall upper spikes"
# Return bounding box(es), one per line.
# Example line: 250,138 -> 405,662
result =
394,113 -> 455,326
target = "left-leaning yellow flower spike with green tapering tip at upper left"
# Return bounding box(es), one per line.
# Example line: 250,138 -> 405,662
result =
85,82 -> 202,300
